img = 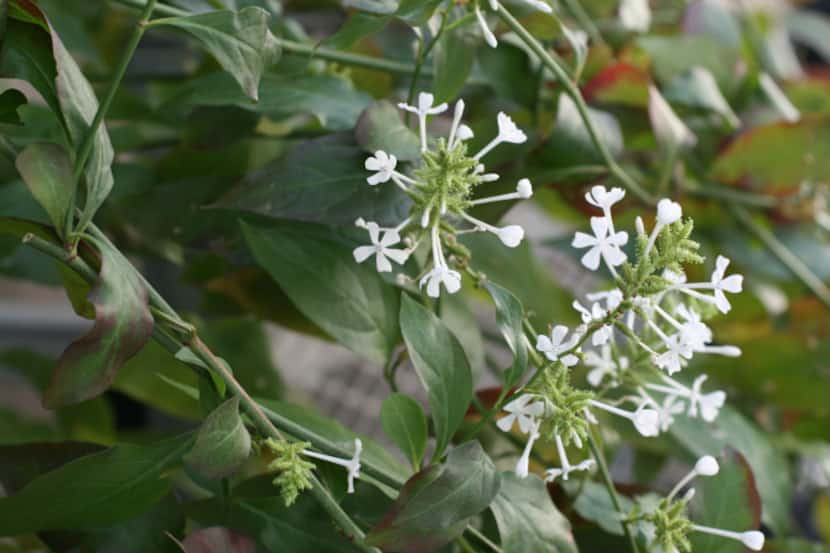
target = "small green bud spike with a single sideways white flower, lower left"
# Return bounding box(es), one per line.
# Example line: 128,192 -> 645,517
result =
264,438 -> 363,507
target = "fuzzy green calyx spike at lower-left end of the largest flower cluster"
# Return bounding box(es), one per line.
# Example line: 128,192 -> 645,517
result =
529,362 -> 594,446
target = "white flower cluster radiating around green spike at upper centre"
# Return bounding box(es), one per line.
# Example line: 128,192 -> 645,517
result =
354,93 -> 533,298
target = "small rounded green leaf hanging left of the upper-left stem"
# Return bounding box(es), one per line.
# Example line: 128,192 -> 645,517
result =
15,144 -> 73,238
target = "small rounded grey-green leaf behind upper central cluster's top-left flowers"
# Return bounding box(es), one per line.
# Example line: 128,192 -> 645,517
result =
355,100 -> 421,161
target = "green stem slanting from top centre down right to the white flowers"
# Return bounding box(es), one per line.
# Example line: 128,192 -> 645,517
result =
497,5 -> 655,205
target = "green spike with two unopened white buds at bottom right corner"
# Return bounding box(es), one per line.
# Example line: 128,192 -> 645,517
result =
626,455 -> 765,553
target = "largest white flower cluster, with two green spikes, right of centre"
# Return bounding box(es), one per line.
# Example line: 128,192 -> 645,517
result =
498,186 -> 743,500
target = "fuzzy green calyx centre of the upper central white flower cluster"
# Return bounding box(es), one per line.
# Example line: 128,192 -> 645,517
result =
412,138 -> 482,225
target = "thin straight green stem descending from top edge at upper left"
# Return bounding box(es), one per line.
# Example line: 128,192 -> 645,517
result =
64,0 -> 156,240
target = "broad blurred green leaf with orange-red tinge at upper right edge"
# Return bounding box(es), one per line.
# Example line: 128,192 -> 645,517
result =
713,115 -> 830,194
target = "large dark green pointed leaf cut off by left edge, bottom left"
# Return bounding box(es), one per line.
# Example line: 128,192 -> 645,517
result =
0,434 -> 193,536
